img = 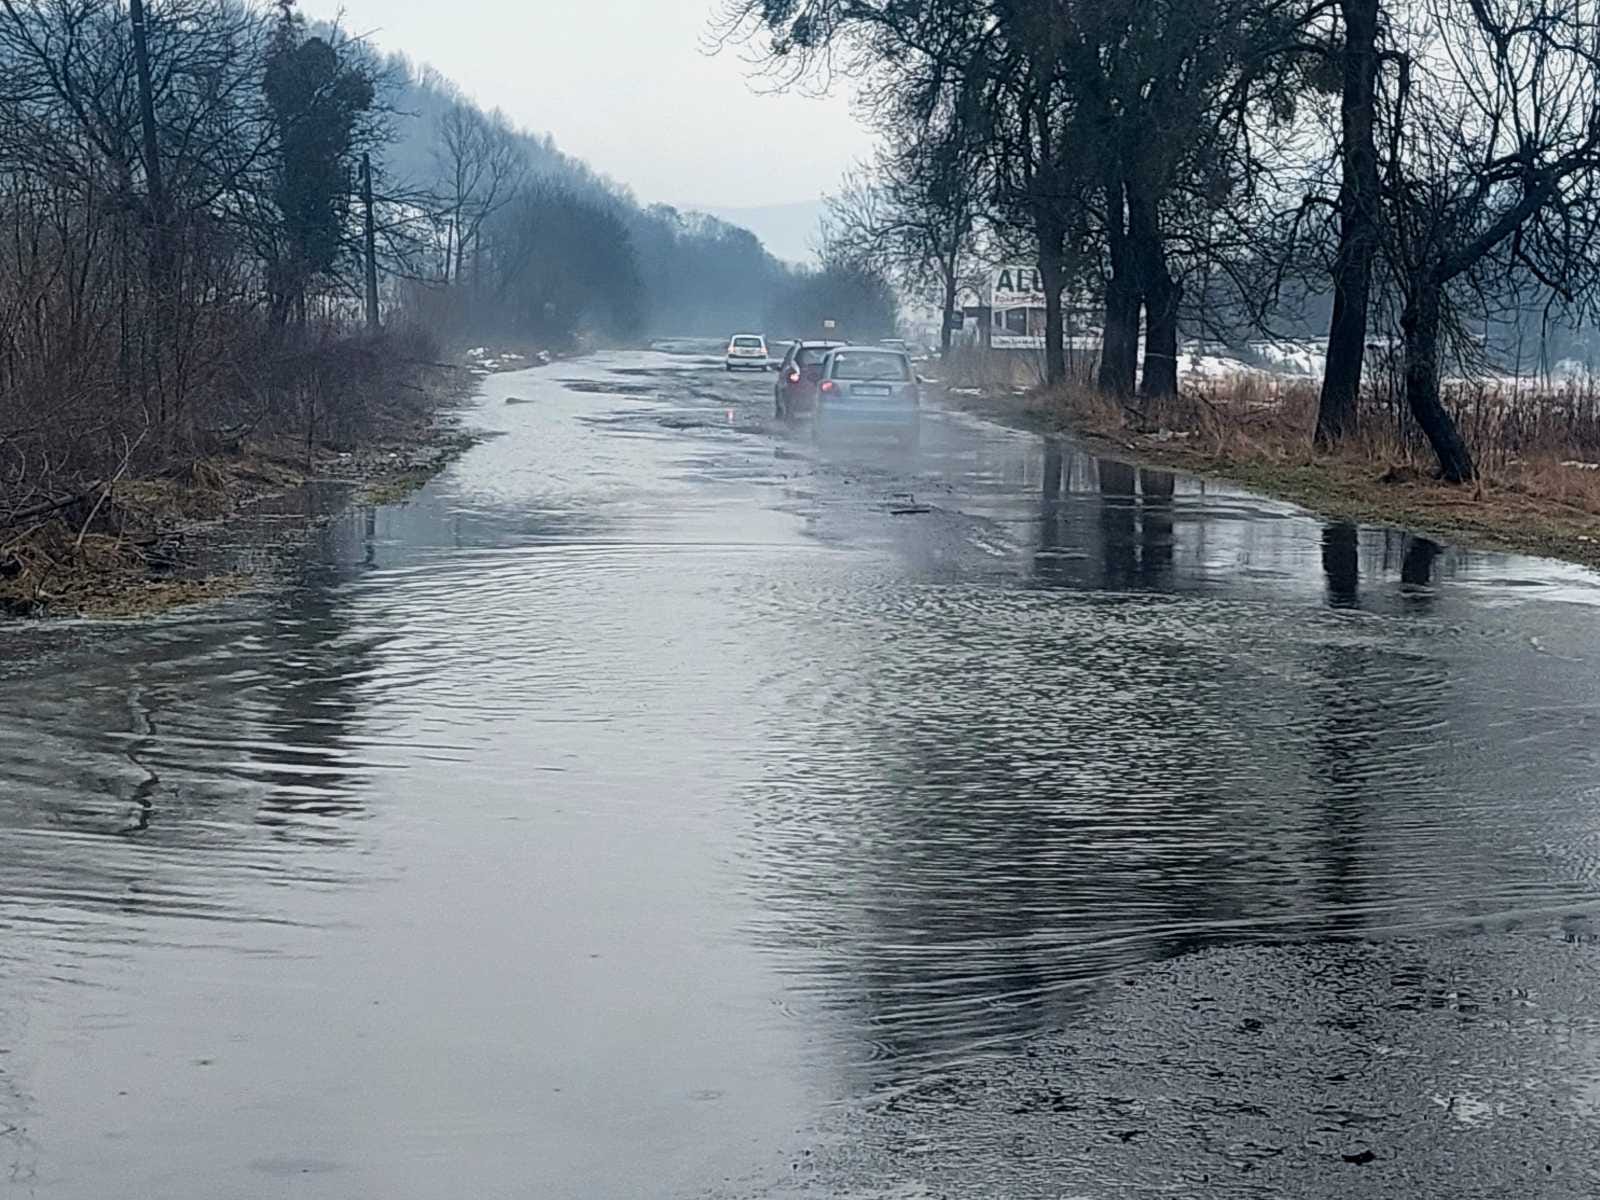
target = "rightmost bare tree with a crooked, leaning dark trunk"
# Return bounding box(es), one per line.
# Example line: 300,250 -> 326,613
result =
1381,0 -> 1600,482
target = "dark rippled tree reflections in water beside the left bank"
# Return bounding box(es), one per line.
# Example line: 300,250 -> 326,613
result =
0,499 -> 376,872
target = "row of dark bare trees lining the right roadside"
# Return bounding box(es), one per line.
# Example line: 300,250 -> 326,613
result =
722,0 -> 1600,482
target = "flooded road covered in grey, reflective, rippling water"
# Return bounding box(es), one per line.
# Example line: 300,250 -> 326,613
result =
0,342 -> 1600,1200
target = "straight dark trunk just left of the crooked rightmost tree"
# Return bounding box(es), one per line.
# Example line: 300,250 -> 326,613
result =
1317,0 -> 1379,446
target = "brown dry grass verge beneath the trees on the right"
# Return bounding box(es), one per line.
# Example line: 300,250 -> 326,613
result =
953,378 -> 1600,566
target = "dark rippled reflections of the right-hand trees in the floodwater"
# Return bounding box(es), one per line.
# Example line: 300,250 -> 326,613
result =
755,446 -> 1491,1077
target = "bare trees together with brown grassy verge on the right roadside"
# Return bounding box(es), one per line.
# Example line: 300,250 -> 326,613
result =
732,0 -> 1600,557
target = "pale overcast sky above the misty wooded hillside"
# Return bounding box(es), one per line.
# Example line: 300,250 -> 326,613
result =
301,0 -> 869,208
